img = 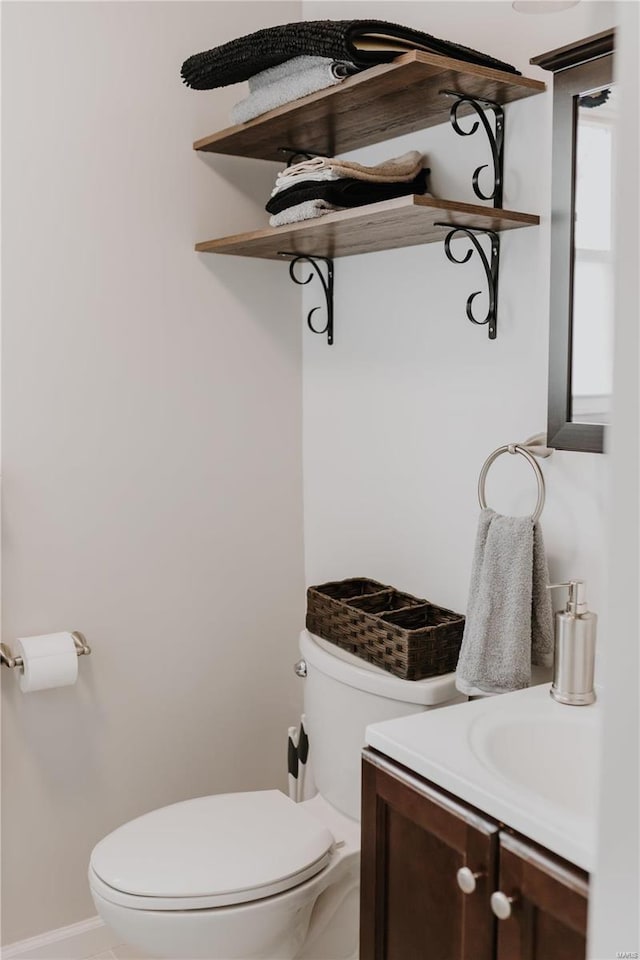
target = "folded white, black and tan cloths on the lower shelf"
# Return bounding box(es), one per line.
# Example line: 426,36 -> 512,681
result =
266,150 -> 429,227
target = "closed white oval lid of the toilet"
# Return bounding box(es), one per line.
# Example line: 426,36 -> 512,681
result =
90,790 -> 334,909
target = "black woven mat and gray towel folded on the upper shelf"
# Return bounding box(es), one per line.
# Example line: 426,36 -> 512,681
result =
181,20 -> 518,123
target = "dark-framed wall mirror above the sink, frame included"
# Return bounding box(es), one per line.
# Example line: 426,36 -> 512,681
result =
531,30 -> 617,453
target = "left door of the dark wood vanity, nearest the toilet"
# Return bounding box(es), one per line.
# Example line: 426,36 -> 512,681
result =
360,751 -> 498,960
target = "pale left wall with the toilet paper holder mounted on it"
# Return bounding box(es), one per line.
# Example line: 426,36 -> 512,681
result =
2,2 -> 304,942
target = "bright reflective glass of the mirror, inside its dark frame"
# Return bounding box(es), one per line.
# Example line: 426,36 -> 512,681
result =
571,85 -> 616,423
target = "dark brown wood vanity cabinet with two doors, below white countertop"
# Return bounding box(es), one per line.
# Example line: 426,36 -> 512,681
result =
360,750 -> 587,960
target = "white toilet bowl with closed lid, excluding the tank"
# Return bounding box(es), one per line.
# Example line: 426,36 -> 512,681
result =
89,790 -> 360,960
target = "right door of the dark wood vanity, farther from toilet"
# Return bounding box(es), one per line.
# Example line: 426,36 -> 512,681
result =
497,833 -> 588,960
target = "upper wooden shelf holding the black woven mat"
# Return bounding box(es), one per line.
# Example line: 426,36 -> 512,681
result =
193,50 -> 546,161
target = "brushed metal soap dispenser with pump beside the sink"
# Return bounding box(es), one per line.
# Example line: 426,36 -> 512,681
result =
548,580 -> 598,707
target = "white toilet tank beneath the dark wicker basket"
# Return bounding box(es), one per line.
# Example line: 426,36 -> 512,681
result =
300,630 -> 467,820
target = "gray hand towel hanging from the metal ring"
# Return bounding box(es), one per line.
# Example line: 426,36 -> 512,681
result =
456,509 -> 553,696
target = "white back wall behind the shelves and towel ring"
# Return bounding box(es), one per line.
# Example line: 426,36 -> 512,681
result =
303,2 -> 614,632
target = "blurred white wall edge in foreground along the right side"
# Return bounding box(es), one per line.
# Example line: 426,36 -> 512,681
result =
589,3 -> 640,960
